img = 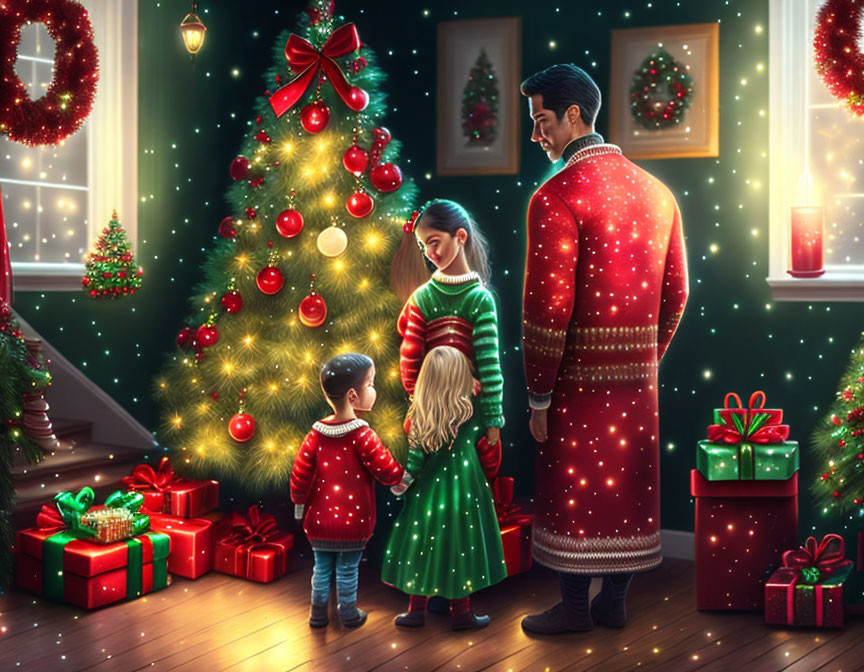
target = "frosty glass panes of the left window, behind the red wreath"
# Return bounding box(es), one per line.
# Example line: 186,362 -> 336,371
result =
0,24 -> 89,264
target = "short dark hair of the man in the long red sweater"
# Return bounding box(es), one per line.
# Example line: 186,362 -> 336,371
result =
522,63 -> 600,126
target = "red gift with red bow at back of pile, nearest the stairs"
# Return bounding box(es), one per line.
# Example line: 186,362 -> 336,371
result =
123,457 -> 219,518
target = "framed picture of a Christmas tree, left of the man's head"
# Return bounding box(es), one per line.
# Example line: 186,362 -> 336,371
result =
437,17 -> 522,175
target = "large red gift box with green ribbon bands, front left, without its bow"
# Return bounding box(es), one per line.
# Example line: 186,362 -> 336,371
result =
15,528 -> 170,609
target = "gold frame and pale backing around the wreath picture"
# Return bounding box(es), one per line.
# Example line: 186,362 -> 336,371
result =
609,23 -> 720,159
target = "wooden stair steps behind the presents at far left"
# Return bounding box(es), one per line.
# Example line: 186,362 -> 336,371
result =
12,418 -> 154,530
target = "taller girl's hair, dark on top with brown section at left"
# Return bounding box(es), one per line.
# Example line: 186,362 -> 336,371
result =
390,198 -> 491,303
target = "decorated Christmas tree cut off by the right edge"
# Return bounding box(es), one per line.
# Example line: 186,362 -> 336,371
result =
811,334 -> 864,518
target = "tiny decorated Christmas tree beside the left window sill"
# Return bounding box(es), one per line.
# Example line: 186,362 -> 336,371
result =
81,210 -> 143,299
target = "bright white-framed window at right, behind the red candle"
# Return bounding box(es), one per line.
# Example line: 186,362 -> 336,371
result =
768,0 -> 864,301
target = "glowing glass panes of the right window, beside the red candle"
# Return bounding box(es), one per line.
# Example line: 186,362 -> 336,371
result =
798,0 -> 864,266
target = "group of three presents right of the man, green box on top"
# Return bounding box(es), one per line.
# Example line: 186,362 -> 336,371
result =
690,392 -> 852,627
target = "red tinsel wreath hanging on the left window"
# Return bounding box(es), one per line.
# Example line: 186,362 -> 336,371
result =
0,0 -> 99,145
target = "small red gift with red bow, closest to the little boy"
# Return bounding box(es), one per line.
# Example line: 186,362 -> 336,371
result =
213,506 -> 294,583
